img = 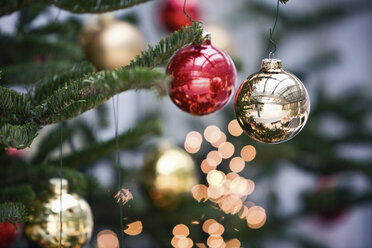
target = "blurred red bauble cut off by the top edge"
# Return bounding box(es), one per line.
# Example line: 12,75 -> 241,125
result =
159,0 -> 199,32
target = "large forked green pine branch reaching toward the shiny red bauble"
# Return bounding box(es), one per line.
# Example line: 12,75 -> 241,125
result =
0,23 -> 204,149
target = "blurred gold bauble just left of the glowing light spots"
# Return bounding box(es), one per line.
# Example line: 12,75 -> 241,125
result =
141,144 -> 198,209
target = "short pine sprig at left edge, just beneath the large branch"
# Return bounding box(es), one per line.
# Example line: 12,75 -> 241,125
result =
0,122 -> 38,149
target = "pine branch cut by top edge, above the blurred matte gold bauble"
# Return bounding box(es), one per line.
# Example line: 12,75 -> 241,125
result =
53,0 -> 150,14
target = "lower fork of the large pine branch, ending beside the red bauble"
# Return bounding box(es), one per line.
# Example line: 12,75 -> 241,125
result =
35,68 -> 168,124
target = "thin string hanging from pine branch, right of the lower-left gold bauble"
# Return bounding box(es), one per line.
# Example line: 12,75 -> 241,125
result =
112,96 -> 124,247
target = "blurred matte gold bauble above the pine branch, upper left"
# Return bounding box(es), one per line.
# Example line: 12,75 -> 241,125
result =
80,16 -> 145,70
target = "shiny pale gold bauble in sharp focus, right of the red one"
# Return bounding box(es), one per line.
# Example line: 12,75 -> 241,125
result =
235,59 -> 310,143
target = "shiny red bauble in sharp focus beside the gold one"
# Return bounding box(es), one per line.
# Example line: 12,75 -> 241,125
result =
167,40 -> 236,115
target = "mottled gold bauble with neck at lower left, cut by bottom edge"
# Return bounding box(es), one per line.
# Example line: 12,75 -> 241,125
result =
25,178 -> 93,248
